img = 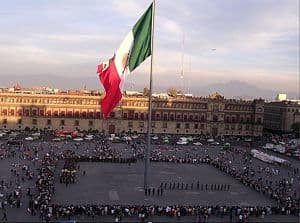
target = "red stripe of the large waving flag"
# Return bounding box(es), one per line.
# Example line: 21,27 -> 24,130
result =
97,58 -> 122,118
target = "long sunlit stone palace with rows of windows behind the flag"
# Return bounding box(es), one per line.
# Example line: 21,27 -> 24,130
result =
0,92 -> 264,136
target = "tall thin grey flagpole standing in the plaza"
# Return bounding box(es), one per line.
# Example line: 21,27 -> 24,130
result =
144,0 -> 155,189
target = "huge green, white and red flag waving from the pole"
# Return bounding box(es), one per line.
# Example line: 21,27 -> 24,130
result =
97,4 -> 152,118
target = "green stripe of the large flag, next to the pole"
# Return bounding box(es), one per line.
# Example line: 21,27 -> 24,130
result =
129,4 -> 152,72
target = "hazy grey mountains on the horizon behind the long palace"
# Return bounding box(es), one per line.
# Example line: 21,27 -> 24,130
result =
0,74 -> 297,100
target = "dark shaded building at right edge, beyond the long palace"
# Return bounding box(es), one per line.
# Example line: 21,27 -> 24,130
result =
264,100 -> 300,132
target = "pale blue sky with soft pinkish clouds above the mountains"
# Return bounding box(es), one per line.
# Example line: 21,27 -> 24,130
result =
0,0 -> 299,95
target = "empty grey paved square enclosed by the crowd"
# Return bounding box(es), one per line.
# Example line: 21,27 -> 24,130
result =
54,162 -> 276,206
